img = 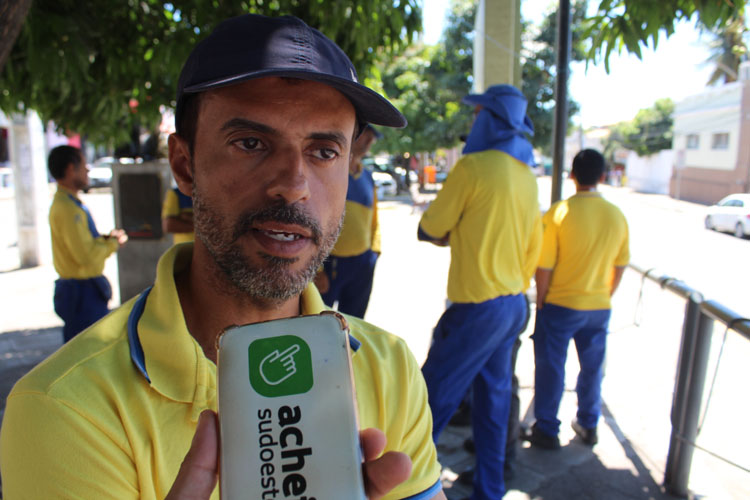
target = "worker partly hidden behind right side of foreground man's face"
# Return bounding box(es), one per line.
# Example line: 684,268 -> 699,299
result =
315,125 -> 382,318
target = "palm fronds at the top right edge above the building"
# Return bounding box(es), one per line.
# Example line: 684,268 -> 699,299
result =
706,16 -> 747,85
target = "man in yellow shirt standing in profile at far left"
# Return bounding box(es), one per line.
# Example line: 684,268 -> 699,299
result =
47,146 -> 128,342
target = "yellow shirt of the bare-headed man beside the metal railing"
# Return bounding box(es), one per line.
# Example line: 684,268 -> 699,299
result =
539,192 -> 630,311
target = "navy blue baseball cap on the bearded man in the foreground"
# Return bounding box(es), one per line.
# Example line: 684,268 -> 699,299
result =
175,14 -> 406,133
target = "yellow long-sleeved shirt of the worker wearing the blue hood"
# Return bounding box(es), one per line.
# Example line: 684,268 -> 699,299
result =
419,150 -> 542,303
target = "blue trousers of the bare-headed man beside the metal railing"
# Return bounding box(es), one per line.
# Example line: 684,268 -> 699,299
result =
531,304 -> 611,436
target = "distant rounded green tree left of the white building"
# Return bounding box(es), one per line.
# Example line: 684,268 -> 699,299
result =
604,98 -> 674,159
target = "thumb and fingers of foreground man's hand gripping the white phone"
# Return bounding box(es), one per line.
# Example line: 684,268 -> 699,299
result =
166,410 -> 411,500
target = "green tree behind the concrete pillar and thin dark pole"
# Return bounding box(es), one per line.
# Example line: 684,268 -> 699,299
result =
375,0 -> 586,157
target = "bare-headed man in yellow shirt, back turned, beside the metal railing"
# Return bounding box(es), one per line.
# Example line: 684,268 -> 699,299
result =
528,149 -> 629,449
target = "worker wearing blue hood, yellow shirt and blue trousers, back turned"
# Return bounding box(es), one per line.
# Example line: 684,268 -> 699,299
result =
418,85 -> 542,500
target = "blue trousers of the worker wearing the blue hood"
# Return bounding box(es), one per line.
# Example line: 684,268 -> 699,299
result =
422,294 -> 526,500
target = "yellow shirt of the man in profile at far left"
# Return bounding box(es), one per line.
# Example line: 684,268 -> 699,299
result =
49,186 -> 119,279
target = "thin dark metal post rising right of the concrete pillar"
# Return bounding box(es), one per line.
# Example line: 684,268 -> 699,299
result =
552,0 -> 572,203
